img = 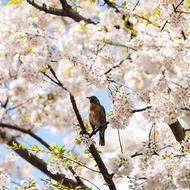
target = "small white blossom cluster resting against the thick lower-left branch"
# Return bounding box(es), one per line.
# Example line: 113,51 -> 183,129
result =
47,157 -> 69,174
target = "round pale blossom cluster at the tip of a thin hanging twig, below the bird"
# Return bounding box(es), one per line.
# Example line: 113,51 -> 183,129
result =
110,155 -> 134,176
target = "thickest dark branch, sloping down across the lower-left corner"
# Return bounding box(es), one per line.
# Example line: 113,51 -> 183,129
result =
7,138 -> 87,189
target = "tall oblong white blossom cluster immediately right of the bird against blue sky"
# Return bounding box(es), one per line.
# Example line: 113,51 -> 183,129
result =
109,87 -> 134,129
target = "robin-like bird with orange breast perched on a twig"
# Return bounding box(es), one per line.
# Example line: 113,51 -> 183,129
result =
87,96 -> 107,146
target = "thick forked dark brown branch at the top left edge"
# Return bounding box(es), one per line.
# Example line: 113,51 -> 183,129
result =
26,0 -> 96,24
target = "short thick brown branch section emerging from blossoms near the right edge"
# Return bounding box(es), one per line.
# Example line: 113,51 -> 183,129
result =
169,120 -> 185,142
